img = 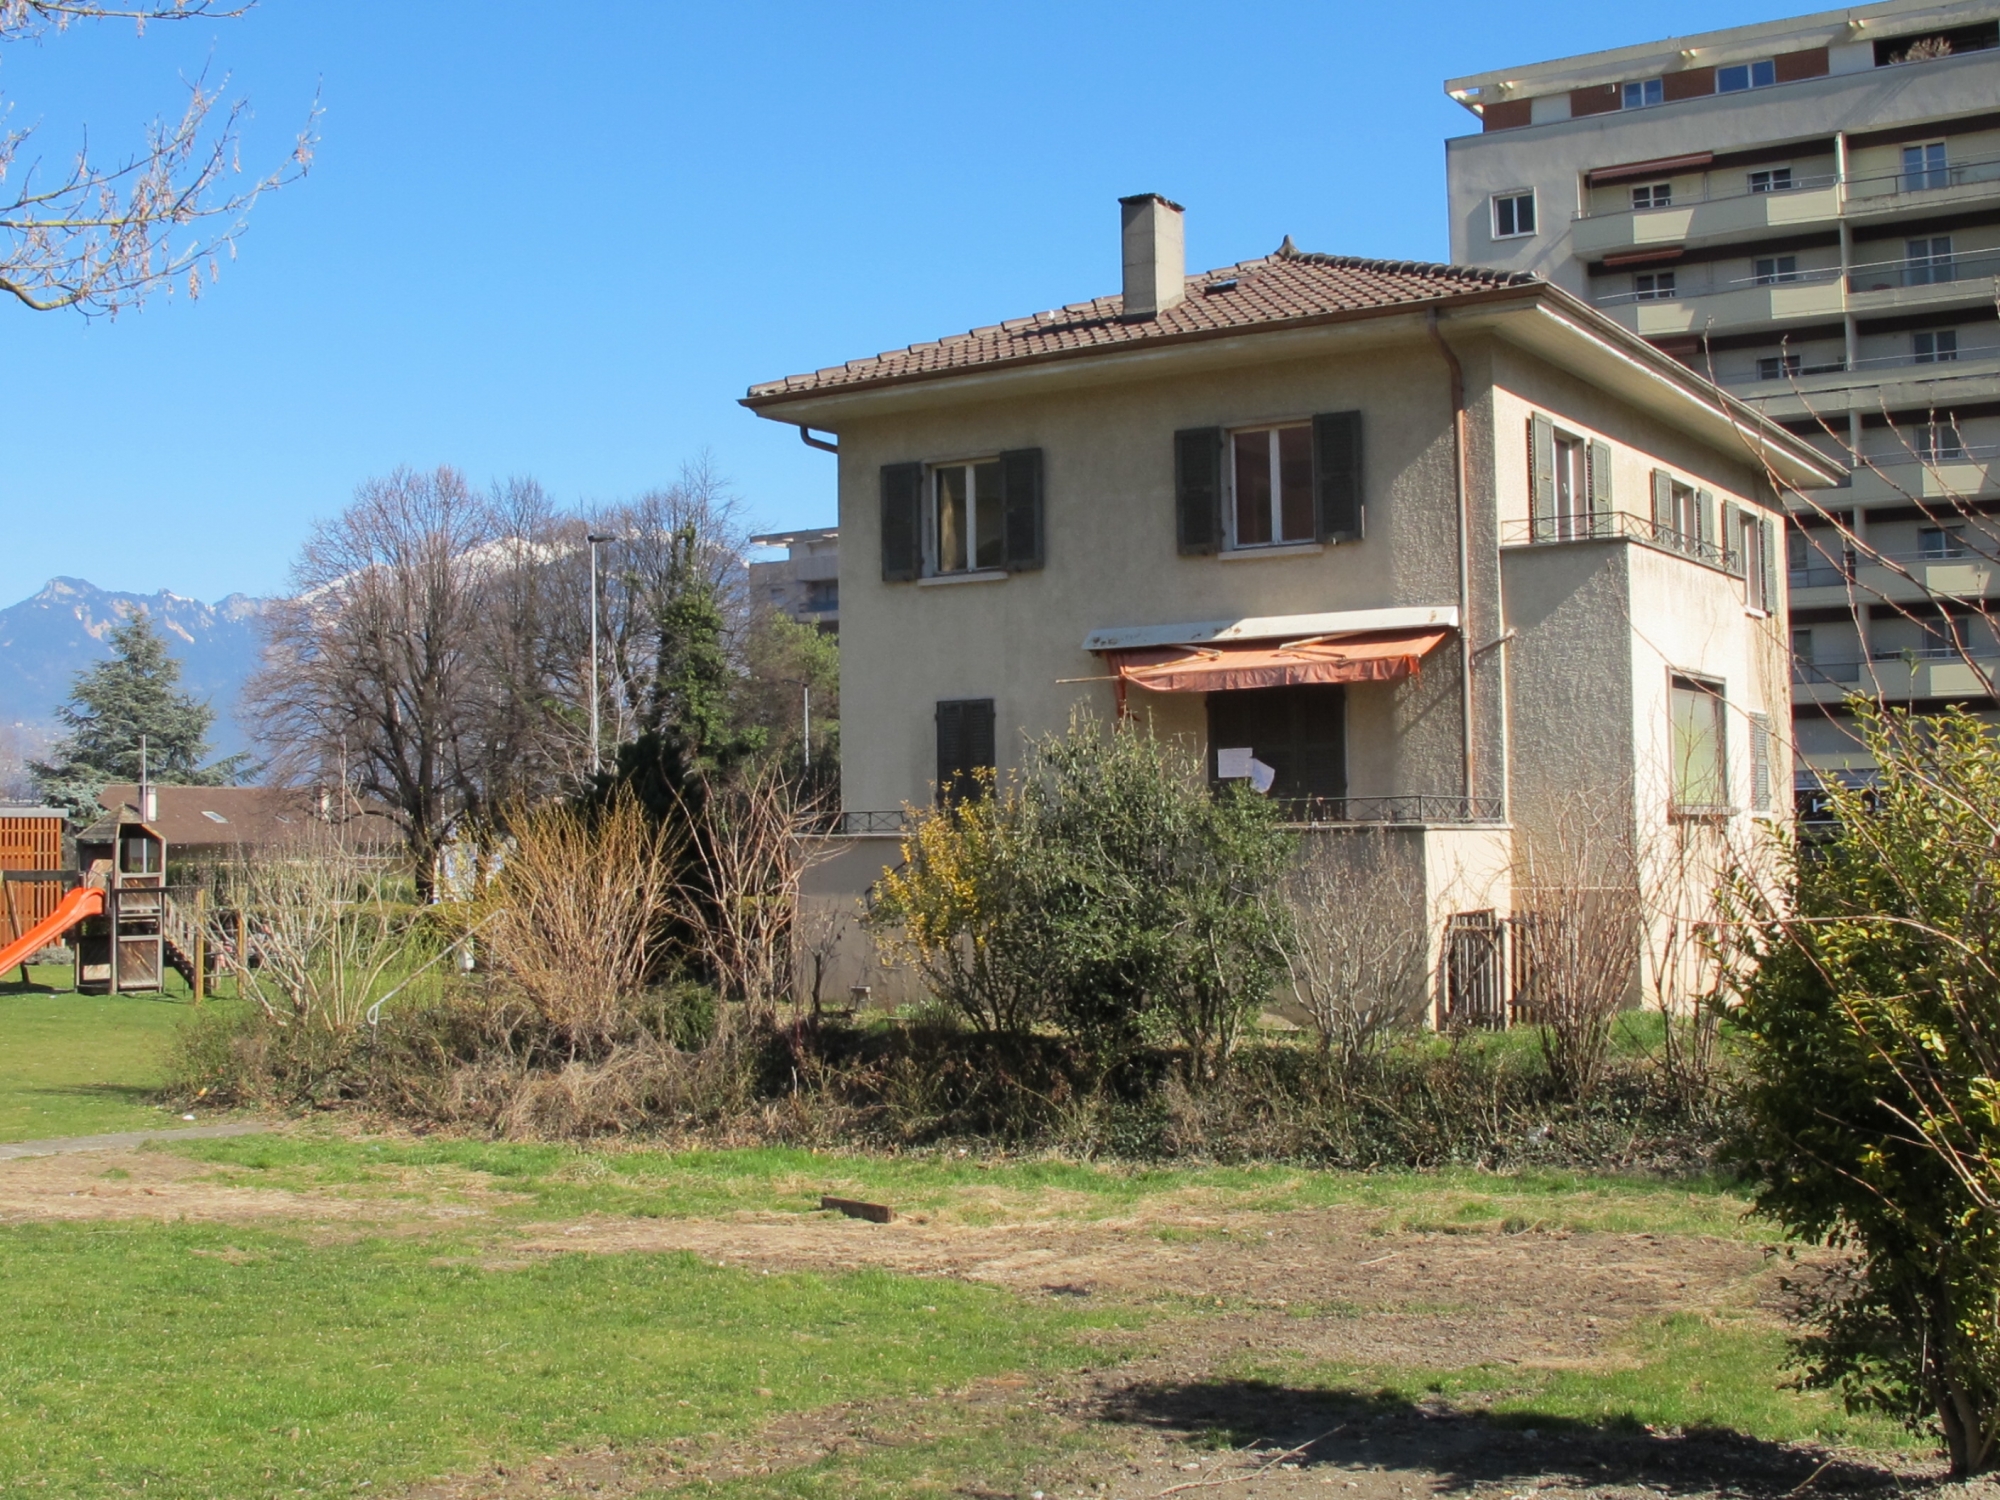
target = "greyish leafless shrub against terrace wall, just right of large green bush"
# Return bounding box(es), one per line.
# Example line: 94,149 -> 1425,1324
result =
1286,830 -> 1428,1080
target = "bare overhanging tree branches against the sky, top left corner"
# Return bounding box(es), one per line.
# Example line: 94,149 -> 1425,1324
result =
0,0 -> 318,314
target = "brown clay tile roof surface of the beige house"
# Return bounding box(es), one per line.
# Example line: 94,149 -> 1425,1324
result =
744,248 -> 1542,406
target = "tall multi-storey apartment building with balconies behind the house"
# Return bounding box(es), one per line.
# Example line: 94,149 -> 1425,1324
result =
1446,0 -> 2000,788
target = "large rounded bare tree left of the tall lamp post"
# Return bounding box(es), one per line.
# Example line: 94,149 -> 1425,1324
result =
244,468 -> 512,900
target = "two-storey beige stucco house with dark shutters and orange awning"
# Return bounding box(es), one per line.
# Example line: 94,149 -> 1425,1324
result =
746,196 -> 1838,1024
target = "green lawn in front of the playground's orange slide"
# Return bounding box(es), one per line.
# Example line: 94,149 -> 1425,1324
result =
0,968 -> 204,1142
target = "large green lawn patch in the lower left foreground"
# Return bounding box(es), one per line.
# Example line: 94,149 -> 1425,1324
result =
0,1224 -> 1134,1500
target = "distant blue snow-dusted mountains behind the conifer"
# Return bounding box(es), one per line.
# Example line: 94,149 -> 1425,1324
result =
0,578 -> 264,754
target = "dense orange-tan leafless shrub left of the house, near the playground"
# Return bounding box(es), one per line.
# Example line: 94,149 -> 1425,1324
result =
478,796 -> 674,1060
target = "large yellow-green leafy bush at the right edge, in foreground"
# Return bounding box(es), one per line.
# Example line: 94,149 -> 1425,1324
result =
1730,702 -> 2000,1474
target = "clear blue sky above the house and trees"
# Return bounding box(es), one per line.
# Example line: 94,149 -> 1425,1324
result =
0,0 -> 1806,604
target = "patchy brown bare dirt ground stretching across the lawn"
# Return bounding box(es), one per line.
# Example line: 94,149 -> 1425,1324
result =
0,1152 -> 2000,1500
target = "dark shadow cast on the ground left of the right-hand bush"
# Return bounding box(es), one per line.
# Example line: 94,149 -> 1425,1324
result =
1104,1380 -> 1910,1496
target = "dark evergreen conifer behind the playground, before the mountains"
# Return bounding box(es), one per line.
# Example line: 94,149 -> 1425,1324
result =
28,610 -> 250,820
